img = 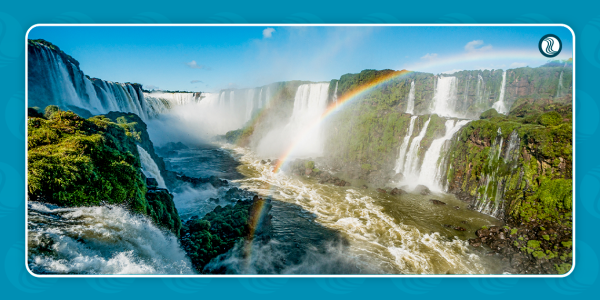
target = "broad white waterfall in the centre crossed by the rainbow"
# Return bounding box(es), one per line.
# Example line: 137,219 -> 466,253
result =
257,83 -> 329,157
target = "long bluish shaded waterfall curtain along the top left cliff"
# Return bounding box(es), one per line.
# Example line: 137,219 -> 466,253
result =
28,43 -> 191,120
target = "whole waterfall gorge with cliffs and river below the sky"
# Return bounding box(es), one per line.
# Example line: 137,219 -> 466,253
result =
28,40 -> 573,274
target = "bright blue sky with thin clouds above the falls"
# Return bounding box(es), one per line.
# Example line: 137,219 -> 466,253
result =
28,26 -> 572,92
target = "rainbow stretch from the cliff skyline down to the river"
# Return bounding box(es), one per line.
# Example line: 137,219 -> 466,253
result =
273,70 -> 412,172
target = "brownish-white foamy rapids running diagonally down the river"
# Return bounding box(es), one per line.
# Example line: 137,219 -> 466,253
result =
225,145 -> 494,274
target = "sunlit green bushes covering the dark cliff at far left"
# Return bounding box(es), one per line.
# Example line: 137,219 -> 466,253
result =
27,106 -> 181,236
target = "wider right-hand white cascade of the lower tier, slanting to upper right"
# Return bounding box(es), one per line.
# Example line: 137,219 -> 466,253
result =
418,120 -> 469,191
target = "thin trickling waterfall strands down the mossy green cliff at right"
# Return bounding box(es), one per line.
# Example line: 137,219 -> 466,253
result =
474,128 -> 520,217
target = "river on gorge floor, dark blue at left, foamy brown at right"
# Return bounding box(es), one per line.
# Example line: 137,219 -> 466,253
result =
166,144 -> 501,274
